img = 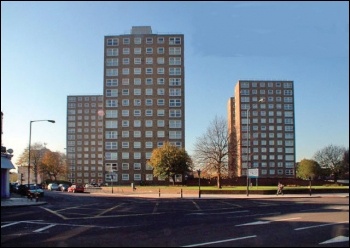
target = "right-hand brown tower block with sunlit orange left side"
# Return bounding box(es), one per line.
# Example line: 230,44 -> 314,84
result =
228,80 -> 295,178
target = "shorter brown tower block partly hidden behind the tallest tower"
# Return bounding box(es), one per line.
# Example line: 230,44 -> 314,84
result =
66,95 -> 104,184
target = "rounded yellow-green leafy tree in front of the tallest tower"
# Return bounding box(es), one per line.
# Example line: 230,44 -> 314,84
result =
148,142 -> 192,184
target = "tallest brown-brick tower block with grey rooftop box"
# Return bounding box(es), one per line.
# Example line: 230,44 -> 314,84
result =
103,26 -> 185,184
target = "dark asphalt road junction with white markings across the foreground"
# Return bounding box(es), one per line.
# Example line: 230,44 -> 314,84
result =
1,191 -> 349,247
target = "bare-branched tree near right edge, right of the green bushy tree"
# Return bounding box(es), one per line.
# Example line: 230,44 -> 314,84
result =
314,145 -> 346,183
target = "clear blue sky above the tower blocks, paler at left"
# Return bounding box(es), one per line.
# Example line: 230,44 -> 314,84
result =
1,1 -> 349,167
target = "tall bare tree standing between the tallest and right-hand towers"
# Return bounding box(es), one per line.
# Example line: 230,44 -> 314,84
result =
193,116 -> 230,188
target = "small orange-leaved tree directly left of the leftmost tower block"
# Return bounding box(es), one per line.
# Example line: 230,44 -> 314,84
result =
40,150 -> 67,181
